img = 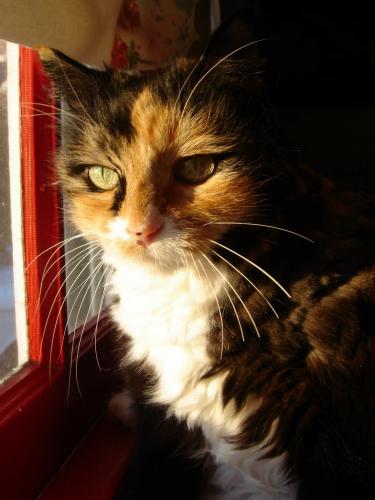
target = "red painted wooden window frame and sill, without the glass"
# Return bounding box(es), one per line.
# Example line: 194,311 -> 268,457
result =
0,47 -> 129,500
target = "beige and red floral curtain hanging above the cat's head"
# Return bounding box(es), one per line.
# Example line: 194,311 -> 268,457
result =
0,0 -> 218,69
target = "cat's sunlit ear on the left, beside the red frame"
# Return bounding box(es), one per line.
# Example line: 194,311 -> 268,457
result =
38,48 -> 108,113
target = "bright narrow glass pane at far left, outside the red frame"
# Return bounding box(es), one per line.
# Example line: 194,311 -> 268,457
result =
0,40 -> 27,382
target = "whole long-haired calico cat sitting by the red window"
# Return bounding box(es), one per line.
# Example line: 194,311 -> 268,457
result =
41,14 -> 375,500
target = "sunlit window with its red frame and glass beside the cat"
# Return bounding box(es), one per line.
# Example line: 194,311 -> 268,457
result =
0,42 -> 128,498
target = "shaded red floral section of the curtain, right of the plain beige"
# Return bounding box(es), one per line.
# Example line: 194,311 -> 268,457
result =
112,0 -> 214,69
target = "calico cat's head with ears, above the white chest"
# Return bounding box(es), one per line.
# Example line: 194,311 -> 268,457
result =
42,15 -> 280,268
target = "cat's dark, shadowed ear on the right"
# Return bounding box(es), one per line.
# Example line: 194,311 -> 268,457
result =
204,10 -> 265,81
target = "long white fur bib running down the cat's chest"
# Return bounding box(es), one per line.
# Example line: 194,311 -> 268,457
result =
108,263 -> 294,500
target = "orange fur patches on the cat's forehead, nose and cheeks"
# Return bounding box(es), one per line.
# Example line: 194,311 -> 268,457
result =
64,84 -> 254,256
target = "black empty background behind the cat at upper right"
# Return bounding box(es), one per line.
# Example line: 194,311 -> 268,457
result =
220,0 -> 375,191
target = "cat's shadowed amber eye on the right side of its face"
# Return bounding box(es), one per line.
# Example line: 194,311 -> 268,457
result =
175,155 -> 216,184
